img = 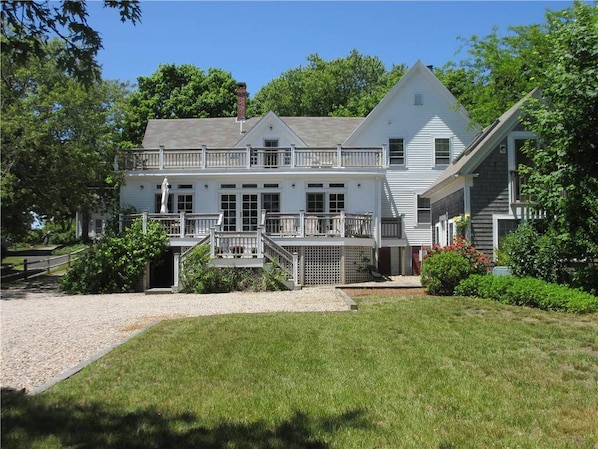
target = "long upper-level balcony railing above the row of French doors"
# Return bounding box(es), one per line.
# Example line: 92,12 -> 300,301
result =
115,145 -> 386,171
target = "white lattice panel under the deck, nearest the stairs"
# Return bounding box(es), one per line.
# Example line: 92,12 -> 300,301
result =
304,246 -> 341,285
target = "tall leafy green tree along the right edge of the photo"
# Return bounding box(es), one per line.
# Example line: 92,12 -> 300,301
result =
522,1 -> 598,260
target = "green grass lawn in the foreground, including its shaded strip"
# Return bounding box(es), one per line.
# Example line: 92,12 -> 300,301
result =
2,295 -> 598,449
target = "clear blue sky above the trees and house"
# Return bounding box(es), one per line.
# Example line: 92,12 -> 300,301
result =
88,0 -> 572,96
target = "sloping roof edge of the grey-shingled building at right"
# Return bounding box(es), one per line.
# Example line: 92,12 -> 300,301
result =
422,88 -> 540,197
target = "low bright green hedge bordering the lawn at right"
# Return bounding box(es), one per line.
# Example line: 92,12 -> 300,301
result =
455,275 -> 598,313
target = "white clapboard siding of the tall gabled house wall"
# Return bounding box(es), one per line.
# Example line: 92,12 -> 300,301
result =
351,70 -> 476,246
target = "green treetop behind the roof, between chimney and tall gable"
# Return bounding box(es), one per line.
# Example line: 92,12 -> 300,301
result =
248,50 -> 406,117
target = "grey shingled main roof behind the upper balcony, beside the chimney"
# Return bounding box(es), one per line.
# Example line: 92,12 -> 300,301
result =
142,112 -> 363,149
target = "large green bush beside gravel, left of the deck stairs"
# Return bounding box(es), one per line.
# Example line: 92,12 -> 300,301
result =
60,219 -> 168,294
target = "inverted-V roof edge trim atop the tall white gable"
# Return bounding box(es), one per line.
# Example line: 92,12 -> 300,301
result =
345,59 -> 470,145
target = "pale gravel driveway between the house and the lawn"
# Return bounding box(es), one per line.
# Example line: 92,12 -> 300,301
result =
0,285 -> 349,390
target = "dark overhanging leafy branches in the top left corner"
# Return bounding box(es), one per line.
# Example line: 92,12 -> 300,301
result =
1,0 -> 141,84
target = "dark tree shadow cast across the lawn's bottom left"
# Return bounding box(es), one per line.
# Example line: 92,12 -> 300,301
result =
2,389 -> 371,449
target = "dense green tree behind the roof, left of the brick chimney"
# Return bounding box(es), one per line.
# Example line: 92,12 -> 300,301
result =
123,64 -> 237,146
